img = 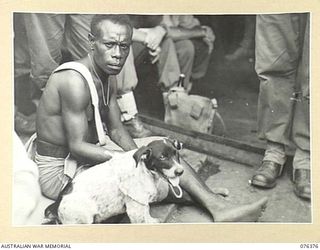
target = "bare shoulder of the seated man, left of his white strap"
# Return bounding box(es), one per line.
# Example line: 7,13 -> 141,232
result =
50,70 -> 90,108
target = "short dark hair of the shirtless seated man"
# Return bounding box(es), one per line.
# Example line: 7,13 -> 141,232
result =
90,14 -> 133,36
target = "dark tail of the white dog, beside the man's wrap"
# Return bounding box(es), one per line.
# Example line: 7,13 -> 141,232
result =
42,181 -> 72,225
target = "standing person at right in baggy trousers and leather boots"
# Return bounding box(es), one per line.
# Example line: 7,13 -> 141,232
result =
252,13 -> 311,200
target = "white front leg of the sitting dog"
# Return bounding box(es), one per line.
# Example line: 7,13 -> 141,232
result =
126,198 -> 160,223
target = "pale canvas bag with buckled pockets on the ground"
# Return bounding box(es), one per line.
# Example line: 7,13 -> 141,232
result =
163,87 -> 218,134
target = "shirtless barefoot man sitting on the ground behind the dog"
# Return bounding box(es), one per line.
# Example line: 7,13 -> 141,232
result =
35,15 -> 267,221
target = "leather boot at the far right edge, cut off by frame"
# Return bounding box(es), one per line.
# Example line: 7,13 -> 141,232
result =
293,169 -> 311,200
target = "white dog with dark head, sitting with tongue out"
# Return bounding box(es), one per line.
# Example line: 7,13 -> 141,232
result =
43,138 -> 184,224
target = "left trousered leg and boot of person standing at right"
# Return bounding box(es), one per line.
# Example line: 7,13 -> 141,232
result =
252,14 -> 299,188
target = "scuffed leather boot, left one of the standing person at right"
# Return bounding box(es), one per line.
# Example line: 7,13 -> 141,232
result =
251,161 -> 282,188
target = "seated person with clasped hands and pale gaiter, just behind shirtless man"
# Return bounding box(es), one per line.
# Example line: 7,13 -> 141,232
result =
112,15 -> 180,138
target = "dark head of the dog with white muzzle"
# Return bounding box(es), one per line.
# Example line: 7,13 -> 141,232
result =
133,138 -> 184,186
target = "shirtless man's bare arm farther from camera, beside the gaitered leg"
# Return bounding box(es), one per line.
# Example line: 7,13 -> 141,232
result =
103,79 -> 137,151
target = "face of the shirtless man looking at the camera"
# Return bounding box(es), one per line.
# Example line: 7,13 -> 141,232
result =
93,20 -> 132,75
